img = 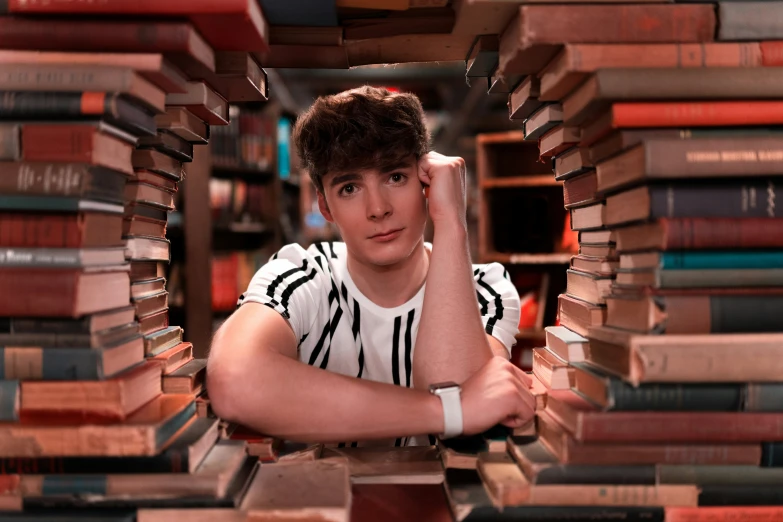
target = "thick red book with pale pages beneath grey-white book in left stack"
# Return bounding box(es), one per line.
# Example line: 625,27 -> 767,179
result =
0,265 -> 130,317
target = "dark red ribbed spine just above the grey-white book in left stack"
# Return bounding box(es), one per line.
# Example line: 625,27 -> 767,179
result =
0,213 -> 82,248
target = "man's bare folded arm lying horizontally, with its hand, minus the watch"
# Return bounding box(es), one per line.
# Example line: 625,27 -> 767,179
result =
207,303 -> 534,442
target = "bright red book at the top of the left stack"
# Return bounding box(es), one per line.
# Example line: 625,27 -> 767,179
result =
6,0 -> 269,52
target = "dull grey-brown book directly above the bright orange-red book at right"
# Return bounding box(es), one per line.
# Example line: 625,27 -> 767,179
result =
563,67 -> 783,125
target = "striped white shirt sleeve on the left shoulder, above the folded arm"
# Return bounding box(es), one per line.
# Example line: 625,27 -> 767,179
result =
237,244 -> 329,340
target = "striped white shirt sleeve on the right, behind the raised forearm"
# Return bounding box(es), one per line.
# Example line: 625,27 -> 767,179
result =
473,263 -> 519,354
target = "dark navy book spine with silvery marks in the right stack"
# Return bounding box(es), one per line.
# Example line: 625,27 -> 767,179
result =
649,180 -> 783,218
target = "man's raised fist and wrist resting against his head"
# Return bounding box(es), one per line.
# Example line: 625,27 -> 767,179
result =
419,148 -> 467,226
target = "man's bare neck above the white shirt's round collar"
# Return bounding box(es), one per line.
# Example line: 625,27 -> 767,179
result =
347,239 -> 430,308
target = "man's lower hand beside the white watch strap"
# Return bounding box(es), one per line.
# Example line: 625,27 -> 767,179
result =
461,357 -> 536,435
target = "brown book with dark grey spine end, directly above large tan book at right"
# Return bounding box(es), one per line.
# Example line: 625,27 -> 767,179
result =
606,288 -> 783,334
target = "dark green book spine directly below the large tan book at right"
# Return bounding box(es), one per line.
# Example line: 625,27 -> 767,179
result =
607,379 -> 743,411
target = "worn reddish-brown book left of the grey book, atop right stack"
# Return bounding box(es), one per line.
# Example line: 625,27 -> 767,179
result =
498,4 -> 716,74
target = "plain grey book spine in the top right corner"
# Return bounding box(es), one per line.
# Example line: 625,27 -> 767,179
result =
718,2 -> 783,41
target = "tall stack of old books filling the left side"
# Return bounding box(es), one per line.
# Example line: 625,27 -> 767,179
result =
0,2 -> 276,520
